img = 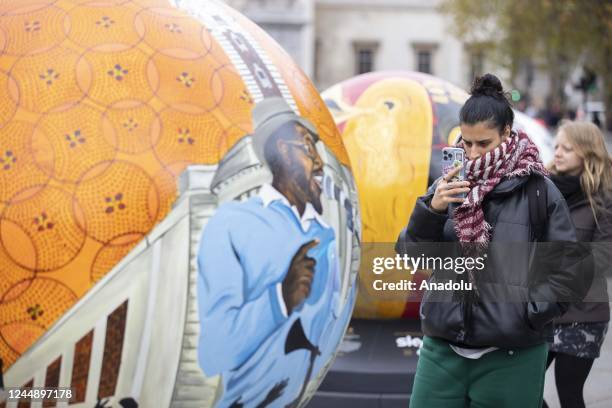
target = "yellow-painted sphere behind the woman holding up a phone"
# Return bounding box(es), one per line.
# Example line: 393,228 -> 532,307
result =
322,71 -> 552,318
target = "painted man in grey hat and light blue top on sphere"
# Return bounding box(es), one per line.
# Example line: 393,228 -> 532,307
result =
198,98 -> 354,407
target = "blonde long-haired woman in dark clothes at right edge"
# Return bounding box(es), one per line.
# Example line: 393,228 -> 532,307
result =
544,122 -> 612,408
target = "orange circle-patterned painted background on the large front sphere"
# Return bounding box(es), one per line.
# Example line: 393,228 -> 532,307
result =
0,0 -> 348,369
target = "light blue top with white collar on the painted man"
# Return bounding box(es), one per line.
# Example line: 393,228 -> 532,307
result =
197,184 -> 355,408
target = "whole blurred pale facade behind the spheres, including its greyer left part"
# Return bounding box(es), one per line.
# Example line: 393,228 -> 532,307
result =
222,0 -> 484,90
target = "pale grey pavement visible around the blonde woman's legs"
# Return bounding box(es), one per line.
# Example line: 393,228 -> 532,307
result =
544,279 -> 612,408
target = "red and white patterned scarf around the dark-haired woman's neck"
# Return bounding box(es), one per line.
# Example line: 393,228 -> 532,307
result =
454,131 -> 548,247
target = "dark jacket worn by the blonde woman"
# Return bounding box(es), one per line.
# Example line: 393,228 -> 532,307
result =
552,176 -> 612,323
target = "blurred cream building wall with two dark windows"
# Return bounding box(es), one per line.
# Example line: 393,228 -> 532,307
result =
314,0 -> 470,89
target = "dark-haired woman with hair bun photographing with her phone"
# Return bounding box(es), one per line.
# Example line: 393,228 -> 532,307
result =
396,74 -> 585,408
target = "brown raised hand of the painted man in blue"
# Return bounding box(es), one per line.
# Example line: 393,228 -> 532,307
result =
282,239 -> 319,314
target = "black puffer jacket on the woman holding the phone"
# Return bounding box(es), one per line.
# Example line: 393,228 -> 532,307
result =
396,176 -> 592,348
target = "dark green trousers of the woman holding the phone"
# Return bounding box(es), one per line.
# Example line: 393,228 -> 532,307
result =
410,336 -> 548,408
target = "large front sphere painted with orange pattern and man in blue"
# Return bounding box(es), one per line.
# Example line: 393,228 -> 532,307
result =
0,0 -> 361,407
